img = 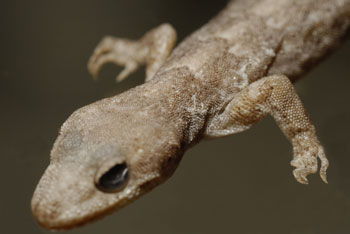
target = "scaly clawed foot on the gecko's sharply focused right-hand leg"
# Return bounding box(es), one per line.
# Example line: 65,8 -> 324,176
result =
291,136 -> 329,184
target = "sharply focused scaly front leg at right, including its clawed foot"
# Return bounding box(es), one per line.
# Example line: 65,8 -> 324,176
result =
206,75 -> 328,184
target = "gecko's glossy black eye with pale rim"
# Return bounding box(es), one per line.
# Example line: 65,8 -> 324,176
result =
97,163 -> 129,192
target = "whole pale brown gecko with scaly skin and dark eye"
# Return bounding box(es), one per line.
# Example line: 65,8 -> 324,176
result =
31,0 -> 350,229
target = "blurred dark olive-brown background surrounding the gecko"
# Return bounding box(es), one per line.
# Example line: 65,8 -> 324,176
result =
0,0 -> 350,234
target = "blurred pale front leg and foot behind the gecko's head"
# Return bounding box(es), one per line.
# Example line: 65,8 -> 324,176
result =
88,24 -> 176,81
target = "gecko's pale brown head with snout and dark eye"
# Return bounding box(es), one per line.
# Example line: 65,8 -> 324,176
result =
31,99 -> 182,229
